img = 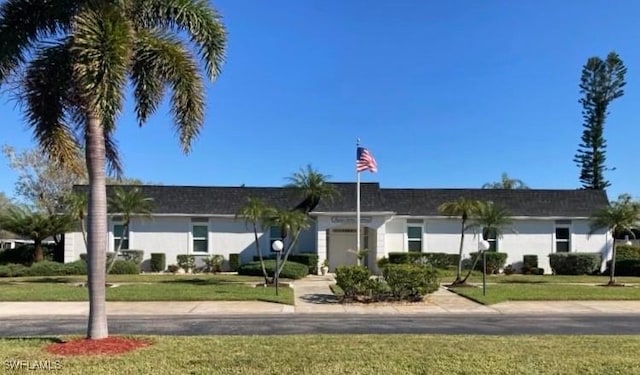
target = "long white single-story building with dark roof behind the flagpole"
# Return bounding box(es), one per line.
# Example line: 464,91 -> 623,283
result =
64,183 -> 613,273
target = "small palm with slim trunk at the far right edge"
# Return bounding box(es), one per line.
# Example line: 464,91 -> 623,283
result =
589,194 -> 640,285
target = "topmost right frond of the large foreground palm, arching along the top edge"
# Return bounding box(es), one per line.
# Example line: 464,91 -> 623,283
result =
130,0 -> 227,80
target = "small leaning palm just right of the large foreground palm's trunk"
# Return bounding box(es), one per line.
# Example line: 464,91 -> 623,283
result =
107,186 -> 153,274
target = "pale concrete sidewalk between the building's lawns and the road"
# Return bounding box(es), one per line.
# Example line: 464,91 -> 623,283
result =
0,275 -> 640,318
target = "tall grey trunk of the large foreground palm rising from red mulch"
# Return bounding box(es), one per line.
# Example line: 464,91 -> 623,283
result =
85,113 -> 109,339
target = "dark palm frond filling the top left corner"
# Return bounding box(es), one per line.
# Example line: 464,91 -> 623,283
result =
0,0 -> 86,84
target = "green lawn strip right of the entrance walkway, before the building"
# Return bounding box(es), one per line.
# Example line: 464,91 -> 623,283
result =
452,283 -> 640,305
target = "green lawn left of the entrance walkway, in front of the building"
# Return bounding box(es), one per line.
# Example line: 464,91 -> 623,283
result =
0,275 -> 293,305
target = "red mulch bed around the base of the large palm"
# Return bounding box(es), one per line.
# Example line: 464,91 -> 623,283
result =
45,336 -> 151,355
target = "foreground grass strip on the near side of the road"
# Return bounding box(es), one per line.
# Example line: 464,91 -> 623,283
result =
0,335 -> 640,375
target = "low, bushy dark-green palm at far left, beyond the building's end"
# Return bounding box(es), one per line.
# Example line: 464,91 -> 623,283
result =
0,207 -> 73,262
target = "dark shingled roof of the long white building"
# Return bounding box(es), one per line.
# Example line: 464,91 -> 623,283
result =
75,183 -> 608,217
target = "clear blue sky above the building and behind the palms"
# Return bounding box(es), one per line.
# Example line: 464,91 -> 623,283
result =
0,0 -> 640,198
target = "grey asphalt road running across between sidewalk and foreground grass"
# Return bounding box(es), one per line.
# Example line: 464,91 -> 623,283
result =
0,314 -> 640,337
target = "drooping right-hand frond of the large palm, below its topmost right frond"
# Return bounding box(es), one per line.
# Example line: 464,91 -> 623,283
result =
134,33 -> 205,153
